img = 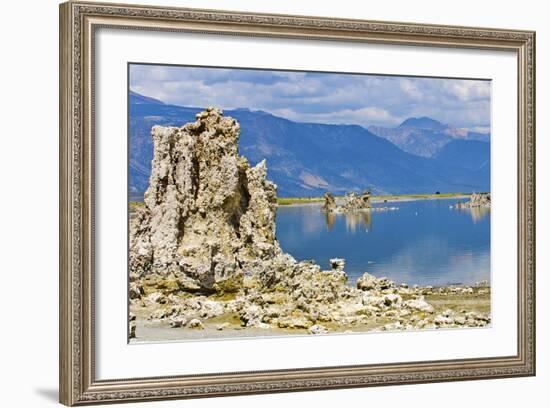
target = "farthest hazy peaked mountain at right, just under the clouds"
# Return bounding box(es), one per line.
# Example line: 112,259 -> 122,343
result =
369,116 -> 490,157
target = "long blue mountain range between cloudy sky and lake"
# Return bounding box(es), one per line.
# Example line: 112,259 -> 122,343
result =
129,92 -> 490,197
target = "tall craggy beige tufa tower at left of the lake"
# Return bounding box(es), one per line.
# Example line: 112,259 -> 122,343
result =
130,108 -> 281,290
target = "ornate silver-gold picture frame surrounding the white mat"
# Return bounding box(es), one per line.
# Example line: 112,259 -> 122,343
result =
59,2 -> 535,405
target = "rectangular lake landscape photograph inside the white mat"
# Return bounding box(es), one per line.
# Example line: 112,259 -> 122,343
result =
129,62 -> 493,344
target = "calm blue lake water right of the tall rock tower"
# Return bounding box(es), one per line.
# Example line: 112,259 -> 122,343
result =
277,198 -> 491,286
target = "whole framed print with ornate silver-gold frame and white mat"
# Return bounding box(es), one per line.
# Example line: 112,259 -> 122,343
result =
60,2 -> 535,405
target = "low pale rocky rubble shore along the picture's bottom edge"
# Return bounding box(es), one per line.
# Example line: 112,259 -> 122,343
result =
130,270 -> 491,342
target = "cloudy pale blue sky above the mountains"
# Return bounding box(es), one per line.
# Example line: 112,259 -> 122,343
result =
130,64 -> 491,131
